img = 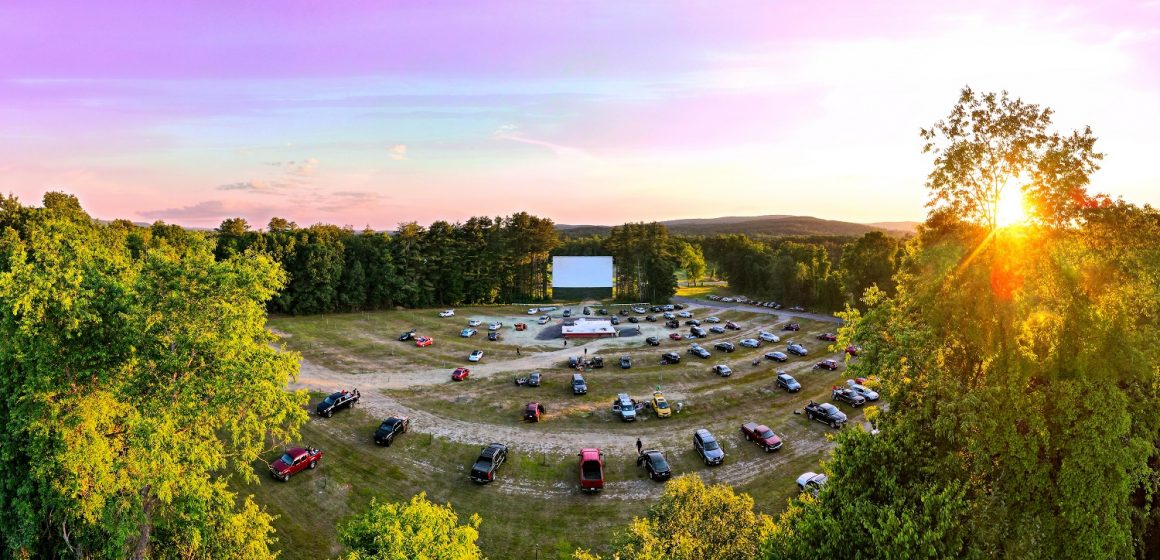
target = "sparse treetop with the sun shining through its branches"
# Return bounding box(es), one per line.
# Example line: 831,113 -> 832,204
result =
920,87 -> 1103,230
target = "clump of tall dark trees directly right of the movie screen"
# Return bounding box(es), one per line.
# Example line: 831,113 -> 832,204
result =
553,223 -> 688,301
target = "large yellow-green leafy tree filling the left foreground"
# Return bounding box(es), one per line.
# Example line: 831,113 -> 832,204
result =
0,194 -> 305,559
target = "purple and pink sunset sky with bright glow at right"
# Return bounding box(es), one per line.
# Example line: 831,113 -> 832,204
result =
0,0 -> 1160,230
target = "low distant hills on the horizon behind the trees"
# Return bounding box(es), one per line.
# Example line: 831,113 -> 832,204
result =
556,214 -> 918,237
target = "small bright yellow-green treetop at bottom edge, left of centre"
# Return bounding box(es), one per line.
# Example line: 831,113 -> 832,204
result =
339,493 -> 483,560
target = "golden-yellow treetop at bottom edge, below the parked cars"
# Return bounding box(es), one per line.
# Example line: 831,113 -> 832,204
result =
574,475 -> 774,560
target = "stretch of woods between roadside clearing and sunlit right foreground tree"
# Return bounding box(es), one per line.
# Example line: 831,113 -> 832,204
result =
694,232 -> 900,311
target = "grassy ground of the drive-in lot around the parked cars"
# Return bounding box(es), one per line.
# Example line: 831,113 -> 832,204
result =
249,307 -> 862,559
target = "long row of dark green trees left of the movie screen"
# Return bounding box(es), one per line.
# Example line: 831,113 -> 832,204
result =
215,212 -> 559,314
